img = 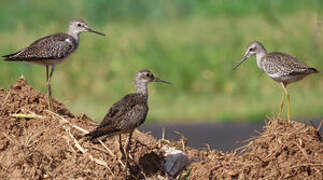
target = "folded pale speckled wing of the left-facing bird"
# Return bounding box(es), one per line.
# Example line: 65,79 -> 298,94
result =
261,52 -> 309,76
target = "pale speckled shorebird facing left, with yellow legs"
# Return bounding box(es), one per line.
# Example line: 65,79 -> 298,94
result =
234,41 -> 319,121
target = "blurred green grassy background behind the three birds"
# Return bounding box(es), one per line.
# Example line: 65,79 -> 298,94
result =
0,0 -> 323,124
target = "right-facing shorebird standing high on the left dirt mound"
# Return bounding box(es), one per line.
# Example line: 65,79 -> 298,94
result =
2,18 -> 105,109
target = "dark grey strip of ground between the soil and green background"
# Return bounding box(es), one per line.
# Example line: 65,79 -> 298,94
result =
139,118 -> 323,152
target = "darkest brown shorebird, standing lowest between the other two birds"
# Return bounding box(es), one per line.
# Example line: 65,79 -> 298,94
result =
85,70 -> 171,177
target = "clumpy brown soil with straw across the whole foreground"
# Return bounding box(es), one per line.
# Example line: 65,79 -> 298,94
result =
0,79 -> 323,179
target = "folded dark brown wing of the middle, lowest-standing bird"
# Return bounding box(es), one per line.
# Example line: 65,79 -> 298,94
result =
86,94 -> 148,139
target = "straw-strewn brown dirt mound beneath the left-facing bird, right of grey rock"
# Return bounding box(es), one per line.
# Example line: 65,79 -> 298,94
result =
190,120 -> 323,179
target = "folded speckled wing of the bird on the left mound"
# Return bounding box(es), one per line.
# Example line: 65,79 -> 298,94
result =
3,33 -> 77,61
